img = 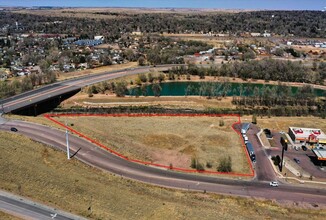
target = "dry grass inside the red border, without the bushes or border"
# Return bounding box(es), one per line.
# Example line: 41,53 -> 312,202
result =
57,116 -> 250,173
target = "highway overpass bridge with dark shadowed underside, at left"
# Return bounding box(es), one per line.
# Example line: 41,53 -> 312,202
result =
0,65 -> 173,115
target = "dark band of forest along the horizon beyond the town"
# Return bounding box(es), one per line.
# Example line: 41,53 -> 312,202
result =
0,10 -> 326,38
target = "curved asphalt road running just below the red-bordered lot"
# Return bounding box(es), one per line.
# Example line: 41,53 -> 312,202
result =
0,121 -> 326,204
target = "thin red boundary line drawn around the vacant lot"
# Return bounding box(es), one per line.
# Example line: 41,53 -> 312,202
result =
44,113 -> 255,177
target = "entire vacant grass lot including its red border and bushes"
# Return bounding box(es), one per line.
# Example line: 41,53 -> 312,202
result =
45,113 -> 254,177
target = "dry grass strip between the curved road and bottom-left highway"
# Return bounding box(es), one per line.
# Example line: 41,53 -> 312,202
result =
0,132 -> 326,220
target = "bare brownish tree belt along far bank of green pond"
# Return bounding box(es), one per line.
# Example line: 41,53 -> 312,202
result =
169,59 -> 326,84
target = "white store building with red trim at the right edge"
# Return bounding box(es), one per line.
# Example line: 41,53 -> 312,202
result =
289,127 -> 326,144
